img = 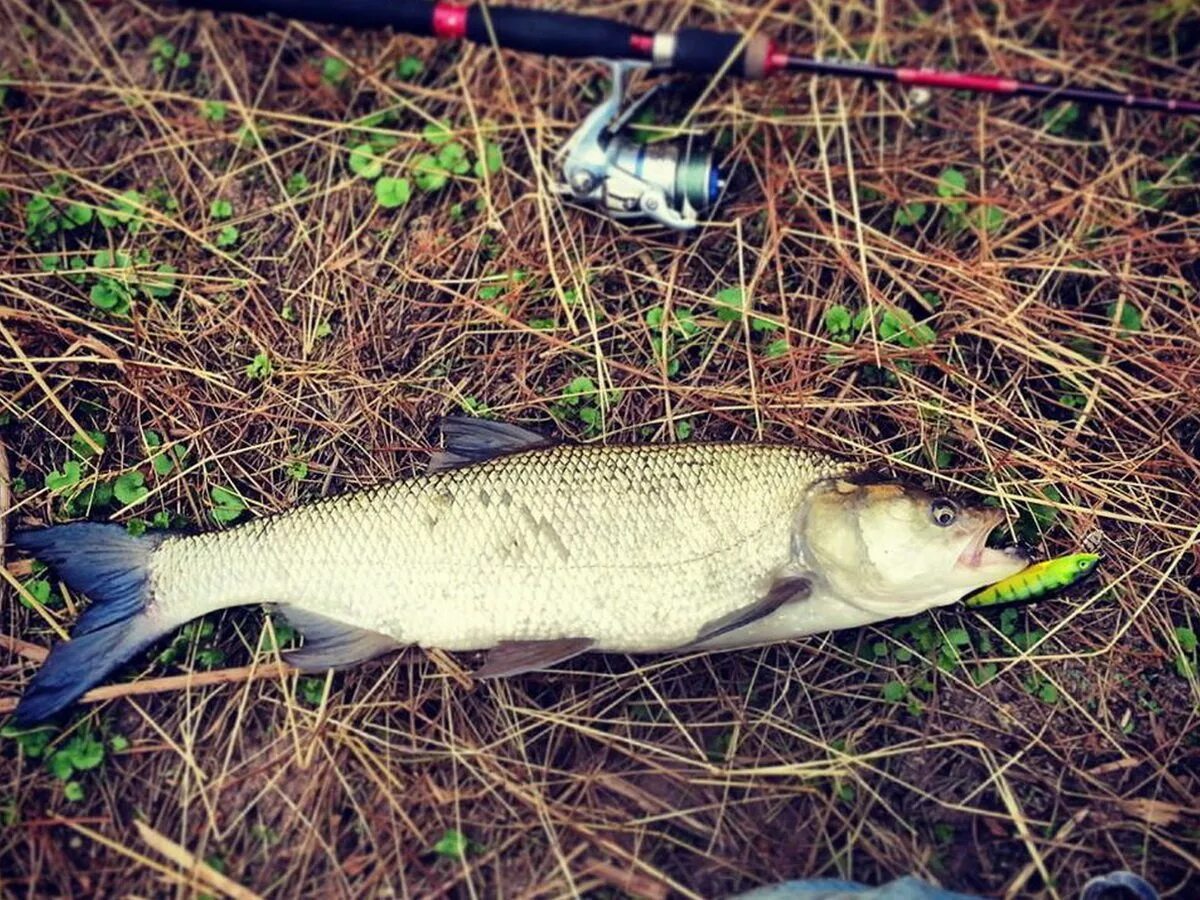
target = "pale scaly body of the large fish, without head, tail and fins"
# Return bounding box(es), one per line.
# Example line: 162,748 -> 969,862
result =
150,444 -> 852,652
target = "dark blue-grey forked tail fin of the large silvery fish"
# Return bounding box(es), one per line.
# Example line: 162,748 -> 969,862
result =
12,522 -> 180,726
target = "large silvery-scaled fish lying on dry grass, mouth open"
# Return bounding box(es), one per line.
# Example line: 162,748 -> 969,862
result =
4,416 -> 1026,725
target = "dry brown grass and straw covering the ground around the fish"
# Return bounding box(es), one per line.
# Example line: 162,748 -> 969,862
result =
0,0 -> 1200,898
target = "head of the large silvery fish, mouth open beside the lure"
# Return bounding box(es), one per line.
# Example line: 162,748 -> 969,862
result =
799,480 -> 1028,618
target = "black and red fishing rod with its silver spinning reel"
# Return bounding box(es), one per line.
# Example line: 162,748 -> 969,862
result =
187,0 -> 1200,229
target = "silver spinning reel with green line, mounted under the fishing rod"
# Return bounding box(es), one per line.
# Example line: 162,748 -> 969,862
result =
556,62 -> 726,230
